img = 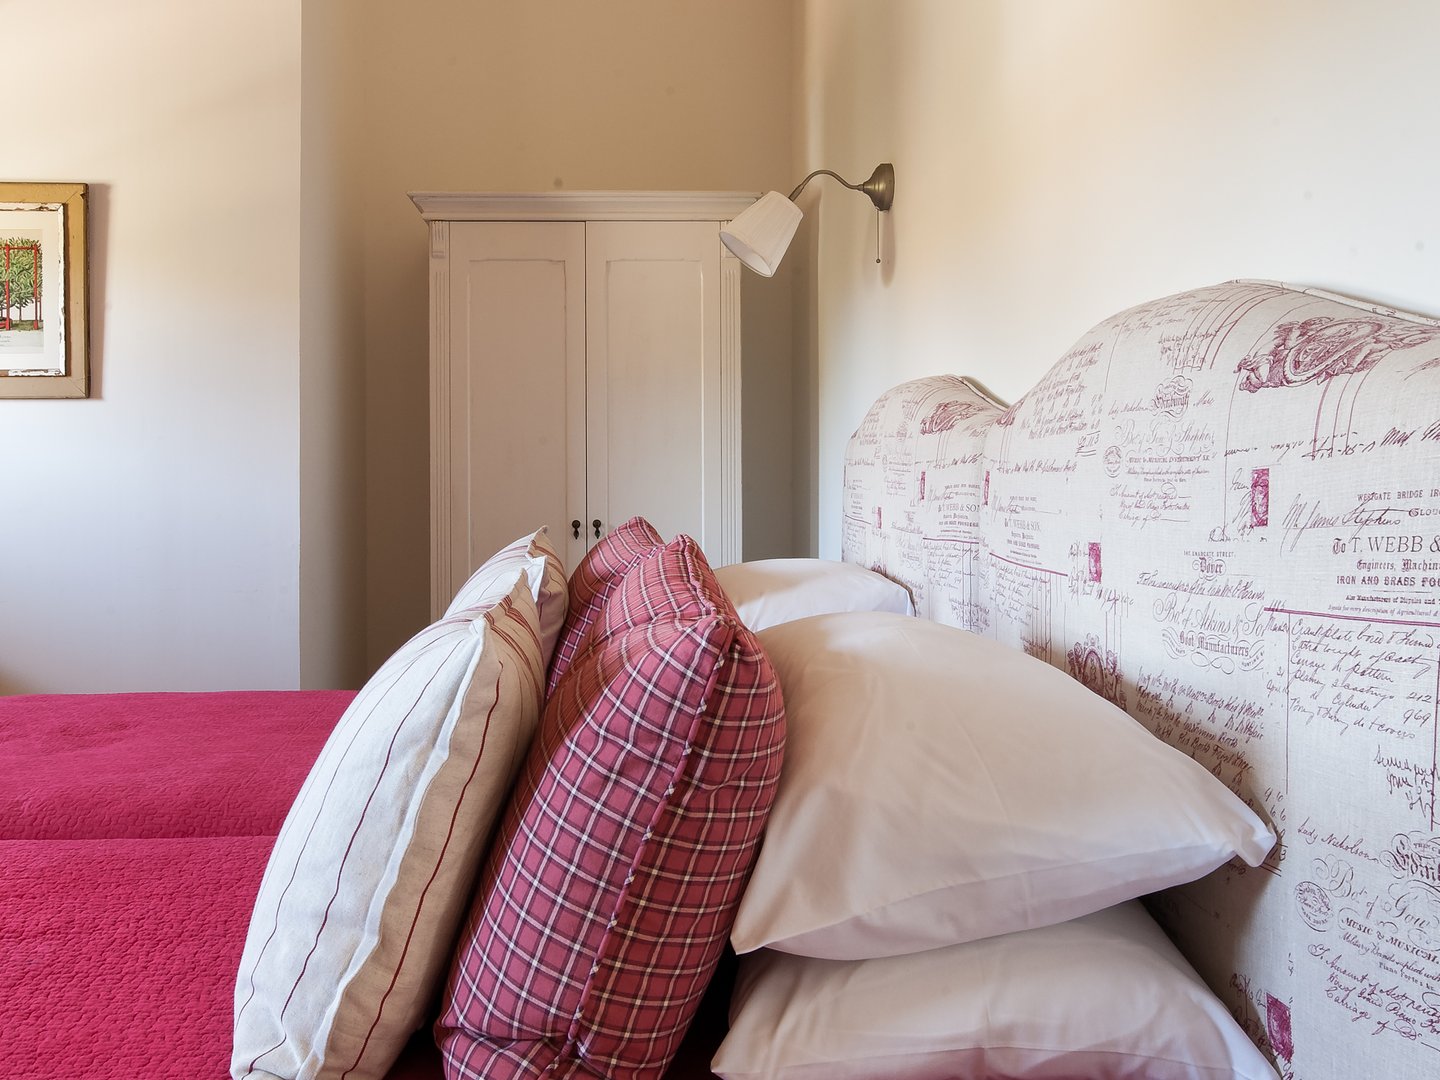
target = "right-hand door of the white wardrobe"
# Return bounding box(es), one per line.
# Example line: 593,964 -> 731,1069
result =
586,222 -> 739,566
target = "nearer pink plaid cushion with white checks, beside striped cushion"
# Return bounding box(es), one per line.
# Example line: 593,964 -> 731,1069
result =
436,537 -> 785,1080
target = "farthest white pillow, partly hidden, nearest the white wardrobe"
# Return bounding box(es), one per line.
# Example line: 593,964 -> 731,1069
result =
716,559 -> 914,632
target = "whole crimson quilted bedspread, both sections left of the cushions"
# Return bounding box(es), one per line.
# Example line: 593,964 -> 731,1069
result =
0,691 -> 714,1080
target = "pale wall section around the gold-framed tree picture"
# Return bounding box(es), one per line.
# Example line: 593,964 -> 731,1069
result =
0,0 -> 301,693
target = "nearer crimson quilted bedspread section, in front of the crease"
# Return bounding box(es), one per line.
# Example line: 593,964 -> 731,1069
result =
0,837 -> 274,1080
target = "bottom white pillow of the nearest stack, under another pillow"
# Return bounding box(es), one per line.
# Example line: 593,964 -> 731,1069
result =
711,901 -> 1276,1080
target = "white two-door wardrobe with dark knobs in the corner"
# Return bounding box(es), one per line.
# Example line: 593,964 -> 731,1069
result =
410,192 -> 755,615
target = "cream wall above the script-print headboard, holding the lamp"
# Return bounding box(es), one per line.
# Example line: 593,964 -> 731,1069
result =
799,0 -> 1440,556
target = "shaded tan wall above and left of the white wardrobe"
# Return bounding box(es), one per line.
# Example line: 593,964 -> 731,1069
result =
353,0 -> 795,665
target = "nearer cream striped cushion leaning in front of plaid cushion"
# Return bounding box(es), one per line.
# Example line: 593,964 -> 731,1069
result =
232,569 -> 544,1080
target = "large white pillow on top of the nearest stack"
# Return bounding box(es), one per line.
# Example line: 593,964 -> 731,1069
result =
732,612 -> 1274,959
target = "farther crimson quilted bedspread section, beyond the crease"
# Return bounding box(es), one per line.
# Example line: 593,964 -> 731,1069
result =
0,690 -> 354,846
